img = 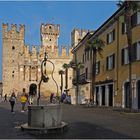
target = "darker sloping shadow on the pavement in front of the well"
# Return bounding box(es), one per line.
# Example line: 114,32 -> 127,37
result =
33,122 -> 132,139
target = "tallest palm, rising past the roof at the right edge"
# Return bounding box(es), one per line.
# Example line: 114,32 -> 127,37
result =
117,0 -> 140,108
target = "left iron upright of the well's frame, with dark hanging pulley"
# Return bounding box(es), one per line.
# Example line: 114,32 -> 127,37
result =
37,52 -> 49,105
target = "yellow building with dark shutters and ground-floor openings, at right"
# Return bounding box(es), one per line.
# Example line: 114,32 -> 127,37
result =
72,5 -> 140,109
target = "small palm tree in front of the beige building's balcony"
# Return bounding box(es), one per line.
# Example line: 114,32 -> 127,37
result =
69,61 -> 84,104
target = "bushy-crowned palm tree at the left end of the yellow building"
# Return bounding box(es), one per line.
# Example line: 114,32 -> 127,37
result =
85,37 -> 105,103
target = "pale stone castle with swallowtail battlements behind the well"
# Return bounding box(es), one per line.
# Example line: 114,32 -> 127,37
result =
2,24 -> 72,96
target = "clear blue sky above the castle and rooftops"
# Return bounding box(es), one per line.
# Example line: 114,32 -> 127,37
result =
0,1 -> 118,80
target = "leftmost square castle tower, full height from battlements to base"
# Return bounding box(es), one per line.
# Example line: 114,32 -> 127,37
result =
2,24 -> 24,94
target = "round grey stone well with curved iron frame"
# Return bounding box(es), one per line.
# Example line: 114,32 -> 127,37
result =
21,52 -> 67,133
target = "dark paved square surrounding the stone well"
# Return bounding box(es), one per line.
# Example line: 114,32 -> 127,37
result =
0,98 -> 140,139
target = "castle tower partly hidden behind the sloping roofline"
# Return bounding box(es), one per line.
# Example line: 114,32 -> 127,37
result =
71,28 -> 89,47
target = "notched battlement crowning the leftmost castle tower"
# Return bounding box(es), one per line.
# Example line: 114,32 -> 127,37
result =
2,23 -> 25,40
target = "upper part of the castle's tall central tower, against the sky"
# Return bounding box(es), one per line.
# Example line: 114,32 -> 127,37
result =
40,24 -> 60,52
